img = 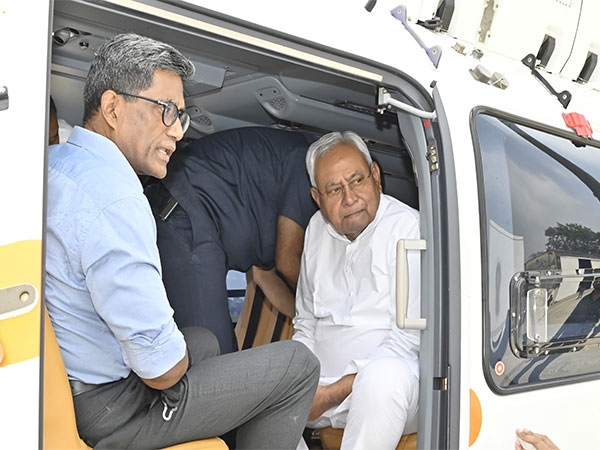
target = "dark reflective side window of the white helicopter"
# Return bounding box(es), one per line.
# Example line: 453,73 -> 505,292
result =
474,113 -> 600,391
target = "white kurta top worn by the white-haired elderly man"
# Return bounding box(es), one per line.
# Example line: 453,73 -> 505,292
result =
293,194 -> 420,446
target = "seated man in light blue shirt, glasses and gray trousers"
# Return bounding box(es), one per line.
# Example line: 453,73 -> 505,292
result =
45,34 -> 319,449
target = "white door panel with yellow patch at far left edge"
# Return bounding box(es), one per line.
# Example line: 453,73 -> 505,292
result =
0,0 -> 50,448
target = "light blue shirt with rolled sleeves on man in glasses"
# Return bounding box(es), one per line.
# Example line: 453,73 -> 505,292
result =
45,127 -> 185,384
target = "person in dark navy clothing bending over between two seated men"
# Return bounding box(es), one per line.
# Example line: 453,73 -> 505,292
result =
146,127 -> 317,353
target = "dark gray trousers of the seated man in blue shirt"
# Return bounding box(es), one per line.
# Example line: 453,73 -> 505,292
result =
74,327 -> 320,450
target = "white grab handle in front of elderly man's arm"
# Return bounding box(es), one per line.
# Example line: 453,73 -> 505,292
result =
396,239 -> 427,330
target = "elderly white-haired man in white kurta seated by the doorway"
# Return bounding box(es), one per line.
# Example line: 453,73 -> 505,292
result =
293,132 -> 420,450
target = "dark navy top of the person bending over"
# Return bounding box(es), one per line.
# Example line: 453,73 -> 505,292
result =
163,127 -> 317,272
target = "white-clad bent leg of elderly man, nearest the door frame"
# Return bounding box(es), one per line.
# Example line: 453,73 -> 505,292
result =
342,358 -> 419,450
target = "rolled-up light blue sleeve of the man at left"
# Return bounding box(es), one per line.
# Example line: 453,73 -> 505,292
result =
81,197 -> 186,378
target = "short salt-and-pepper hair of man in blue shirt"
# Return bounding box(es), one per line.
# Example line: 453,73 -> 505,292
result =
83,33 -> 195,124
